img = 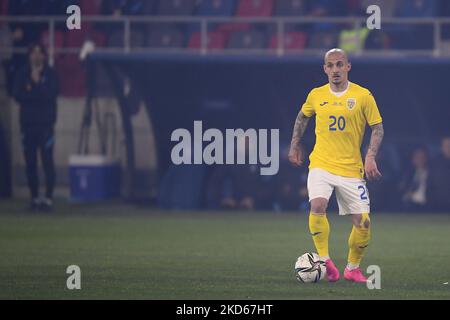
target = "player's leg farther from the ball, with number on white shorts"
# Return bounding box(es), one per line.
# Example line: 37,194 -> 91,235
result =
336,178 -> 370,282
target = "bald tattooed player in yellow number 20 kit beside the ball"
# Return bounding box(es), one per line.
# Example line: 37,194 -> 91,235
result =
289,49 -> 384,282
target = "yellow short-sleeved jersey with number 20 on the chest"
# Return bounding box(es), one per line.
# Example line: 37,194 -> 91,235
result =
301,82 -> 382,178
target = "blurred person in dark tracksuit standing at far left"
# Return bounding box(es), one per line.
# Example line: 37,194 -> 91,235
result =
13,44 -> 58,210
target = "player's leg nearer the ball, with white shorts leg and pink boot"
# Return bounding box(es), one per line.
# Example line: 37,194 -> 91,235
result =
308,169 -> 339,281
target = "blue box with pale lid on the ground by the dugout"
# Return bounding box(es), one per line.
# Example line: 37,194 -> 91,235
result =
69,155 -> 121,202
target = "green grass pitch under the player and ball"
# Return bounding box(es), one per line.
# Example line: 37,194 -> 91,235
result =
0,201 -> 450,299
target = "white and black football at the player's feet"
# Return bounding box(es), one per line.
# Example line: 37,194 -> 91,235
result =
294,252 -> 326,283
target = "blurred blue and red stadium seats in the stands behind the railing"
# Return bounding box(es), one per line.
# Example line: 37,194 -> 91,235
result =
6,0 -> 450,99
